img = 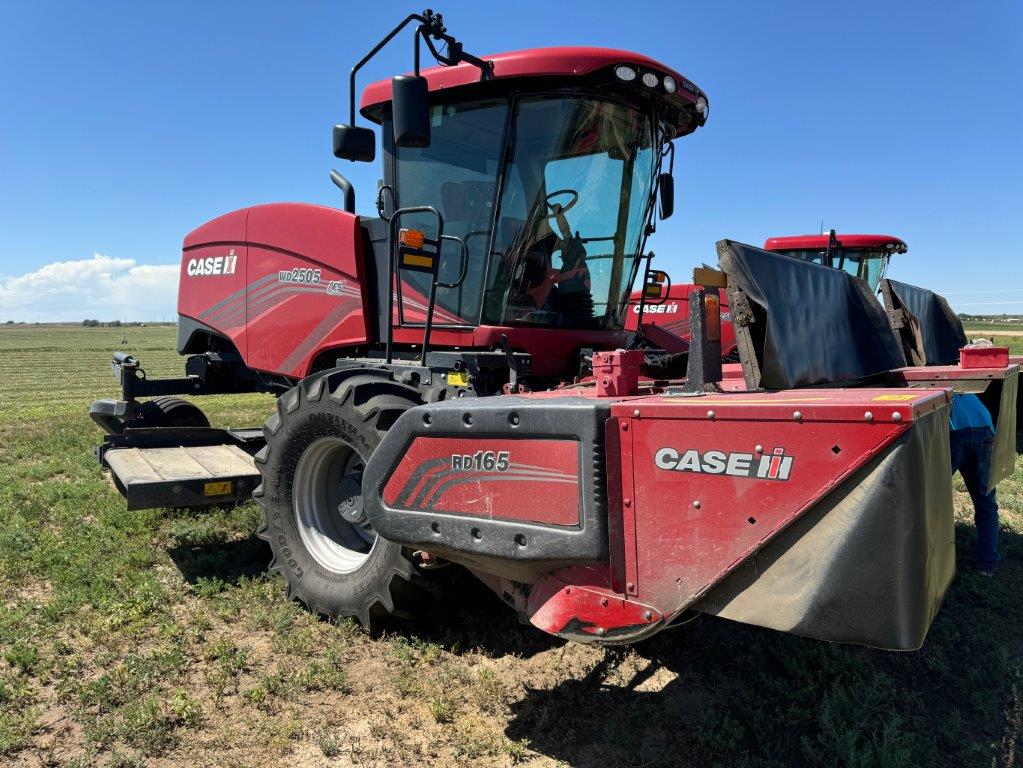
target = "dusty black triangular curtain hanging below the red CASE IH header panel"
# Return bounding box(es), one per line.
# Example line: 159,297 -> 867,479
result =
695,406 -> 955,650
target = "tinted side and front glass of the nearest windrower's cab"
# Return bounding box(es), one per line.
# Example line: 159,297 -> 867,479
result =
385,89 -> 664,329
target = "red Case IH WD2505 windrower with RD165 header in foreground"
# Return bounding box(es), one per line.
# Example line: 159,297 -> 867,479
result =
93,12 -> 1017,648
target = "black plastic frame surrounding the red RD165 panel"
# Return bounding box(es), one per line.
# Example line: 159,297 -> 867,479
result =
362,396 -> 611,579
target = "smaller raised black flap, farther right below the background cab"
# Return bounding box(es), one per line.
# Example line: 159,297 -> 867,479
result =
880,279 -> 968,365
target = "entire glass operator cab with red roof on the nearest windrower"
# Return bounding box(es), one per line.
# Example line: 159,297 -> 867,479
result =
336,17 -> 708,364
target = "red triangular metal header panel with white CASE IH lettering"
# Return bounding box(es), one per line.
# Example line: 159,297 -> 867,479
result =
630,407 -> 908,615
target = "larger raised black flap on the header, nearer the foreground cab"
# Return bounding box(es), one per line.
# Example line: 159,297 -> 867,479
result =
717,240 -> 905,390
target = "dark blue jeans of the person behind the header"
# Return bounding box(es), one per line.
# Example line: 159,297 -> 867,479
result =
948,426 -> 998,571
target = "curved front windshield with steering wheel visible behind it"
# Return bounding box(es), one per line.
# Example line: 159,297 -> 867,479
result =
482,94 -> 657,328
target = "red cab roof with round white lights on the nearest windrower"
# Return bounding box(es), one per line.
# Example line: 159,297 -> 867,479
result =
359,47 -> 707,136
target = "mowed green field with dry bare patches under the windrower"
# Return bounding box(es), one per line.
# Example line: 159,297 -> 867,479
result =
0,326 -> 1023,768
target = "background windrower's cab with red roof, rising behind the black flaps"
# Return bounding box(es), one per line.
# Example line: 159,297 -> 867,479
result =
764,229 -> 907,293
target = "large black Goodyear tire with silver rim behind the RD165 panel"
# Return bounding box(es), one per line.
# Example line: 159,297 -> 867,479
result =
253,371 -> 430,629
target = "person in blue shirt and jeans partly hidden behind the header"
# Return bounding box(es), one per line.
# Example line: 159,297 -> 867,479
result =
948,395 -> 998,576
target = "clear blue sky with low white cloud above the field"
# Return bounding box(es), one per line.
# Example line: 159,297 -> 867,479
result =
0,0 -> 1023,321
